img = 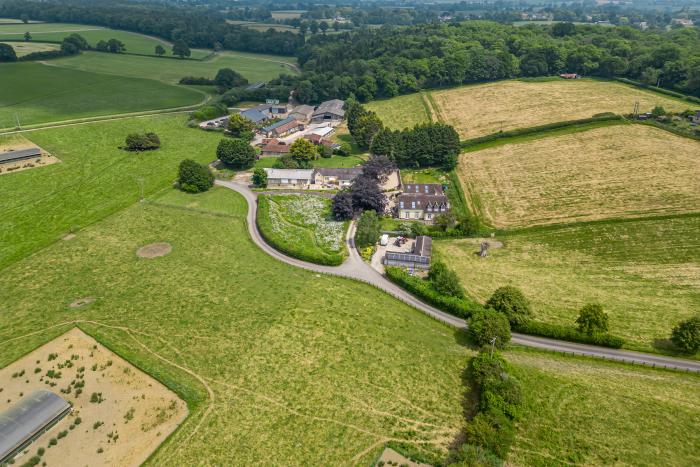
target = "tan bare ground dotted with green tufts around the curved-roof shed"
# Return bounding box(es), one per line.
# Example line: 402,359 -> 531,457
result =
0,328 -> 187,466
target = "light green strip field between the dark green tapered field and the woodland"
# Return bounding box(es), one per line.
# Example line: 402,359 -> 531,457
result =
51,52 -> 296,83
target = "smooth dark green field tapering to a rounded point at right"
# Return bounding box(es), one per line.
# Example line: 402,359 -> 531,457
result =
0,62 -> 204,128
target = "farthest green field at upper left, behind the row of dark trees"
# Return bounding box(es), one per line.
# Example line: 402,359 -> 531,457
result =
0,23 -> 210,58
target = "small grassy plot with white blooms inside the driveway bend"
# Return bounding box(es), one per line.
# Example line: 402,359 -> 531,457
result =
257,195 -> 348,265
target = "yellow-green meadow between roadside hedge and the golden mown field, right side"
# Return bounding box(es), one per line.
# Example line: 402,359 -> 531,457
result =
434,215 -> 700,351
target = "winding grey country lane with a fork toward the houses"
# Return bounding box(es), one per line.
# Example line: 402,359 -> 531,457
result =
216,180 -> 700,373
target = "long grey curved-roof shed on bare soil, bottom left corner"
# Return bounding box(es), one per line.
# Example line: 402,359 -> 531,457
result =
0,389 -> 72,465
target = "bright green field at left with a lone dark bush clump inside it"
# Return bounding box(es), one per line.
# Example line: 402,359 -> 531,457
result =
0,116 -> 221,269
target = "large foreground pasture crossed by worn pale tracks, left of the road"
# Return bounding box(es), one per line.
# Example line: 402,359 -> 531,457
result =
0,188 -> 470,465
